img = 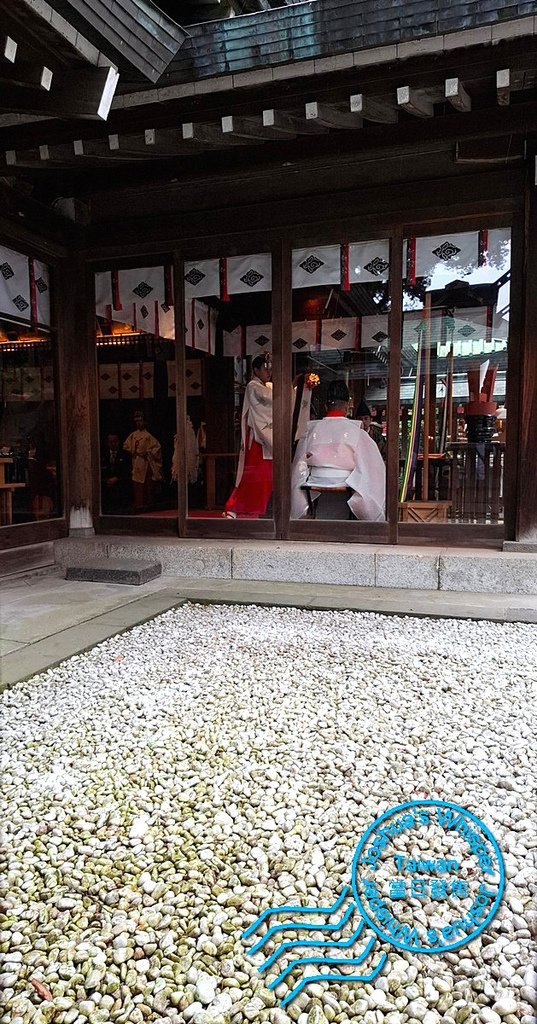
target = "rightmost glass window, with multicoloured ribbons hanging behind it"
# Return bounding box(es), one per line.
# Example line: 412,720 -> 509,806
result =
400,228 -> 510,523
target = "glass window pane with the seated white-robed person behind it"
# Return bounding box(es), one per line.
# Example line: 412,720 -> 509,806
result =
291,239 -> 389,522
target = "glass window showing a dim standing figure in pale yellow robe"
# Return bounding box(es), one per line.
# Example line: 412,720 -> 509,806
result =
95,266 -> 177,517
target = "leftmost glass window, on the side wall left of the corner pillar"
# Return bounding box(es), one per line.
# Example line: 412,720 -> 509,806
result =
0,247 -> 61,526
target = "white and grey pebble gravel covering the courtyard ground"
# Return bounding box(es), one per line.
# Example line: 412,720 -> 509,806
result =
0,604 -> 537,1024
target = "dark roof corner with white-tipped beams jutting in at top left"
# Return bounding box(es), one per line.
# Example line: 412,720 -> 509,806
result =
0,0 -> 187,127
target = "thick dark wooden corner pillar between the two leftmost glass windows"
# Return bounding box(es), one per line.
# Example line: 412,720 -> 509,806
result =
54,255 -> 99,537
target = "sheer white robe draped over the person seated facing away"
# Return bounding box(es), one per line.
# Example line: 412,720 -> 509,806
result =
291,416 -> 386,522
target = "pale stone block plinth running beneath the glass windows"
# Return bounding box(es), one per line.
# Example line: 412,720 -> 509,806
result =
54,537 -> 537,595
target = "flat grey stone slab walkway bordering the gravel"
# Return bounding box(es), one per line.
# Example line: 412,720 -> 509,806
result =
0,572 -> 537,688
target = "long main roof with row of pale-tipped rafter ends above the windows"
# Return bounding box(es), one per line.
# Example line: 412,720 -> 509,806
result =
0,0 -> 537,205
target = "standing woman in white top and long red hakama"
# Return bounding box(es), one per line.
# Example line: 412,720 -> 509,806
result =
223,356 -> 273,519
